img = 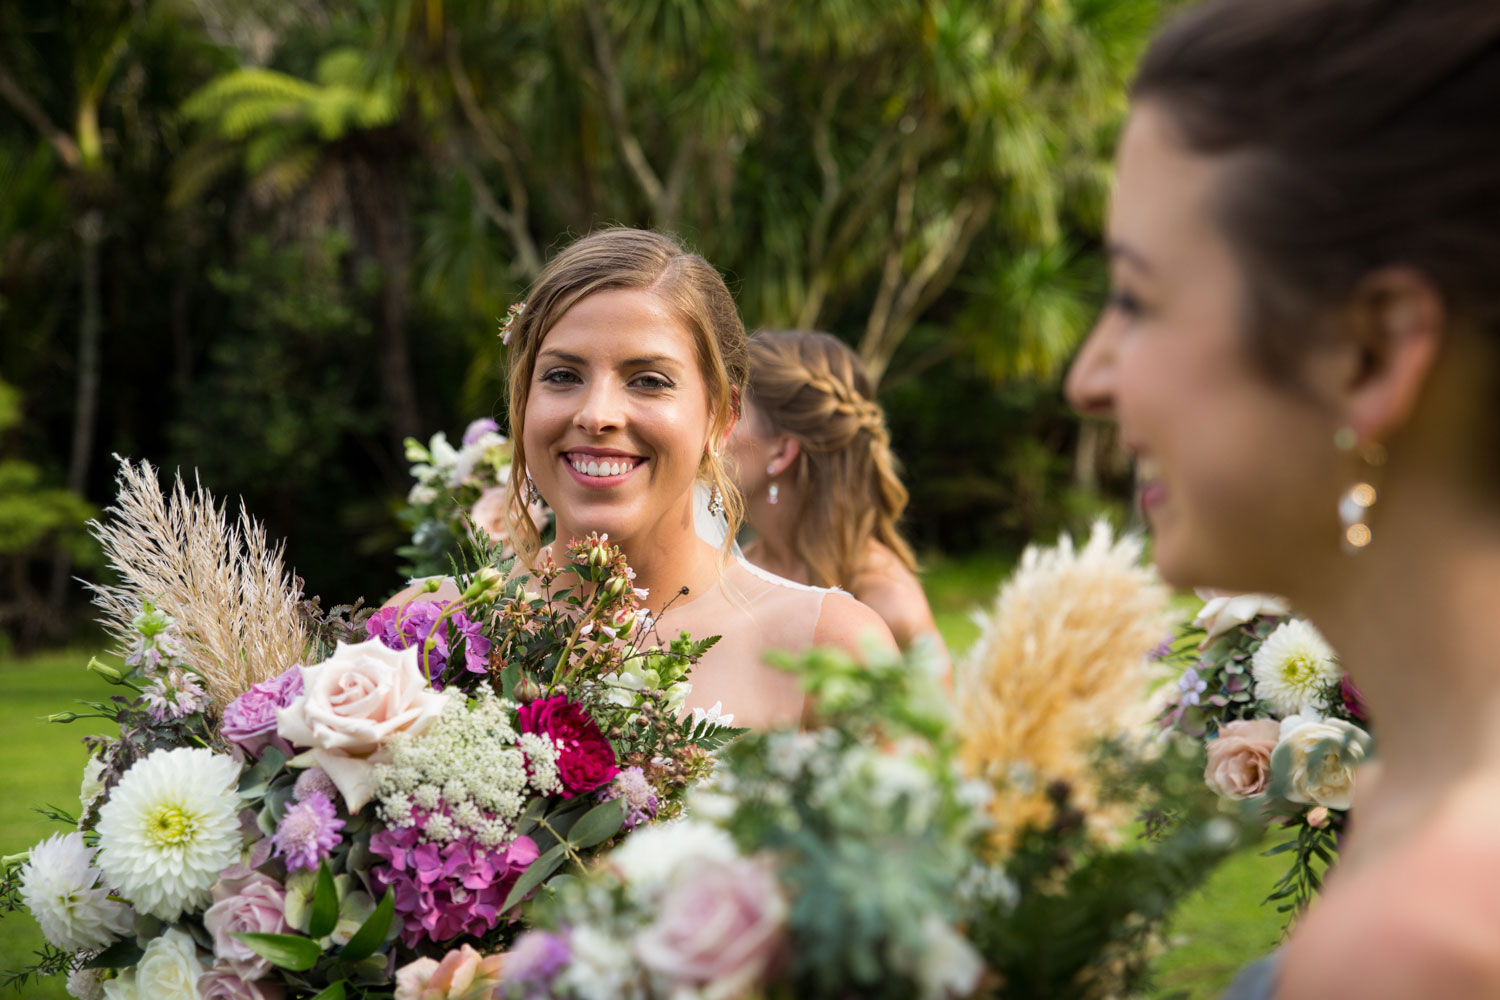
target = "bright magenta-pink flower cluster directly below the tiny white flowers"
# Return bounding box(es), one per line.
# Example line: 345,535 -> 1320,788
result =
371,808 -> 539,948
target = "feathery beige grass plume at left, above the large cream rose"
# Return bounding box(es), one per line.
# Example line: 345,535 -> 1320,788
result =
89,456 -> 308,708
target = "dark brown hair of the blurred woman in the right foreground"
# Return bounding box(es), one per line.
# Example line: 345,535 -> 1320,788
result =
1133,0 -> 1500,376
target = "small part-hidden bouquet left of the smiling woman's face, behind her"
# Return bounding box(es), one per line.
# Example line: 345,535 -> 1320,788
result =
398,417 -> 549,577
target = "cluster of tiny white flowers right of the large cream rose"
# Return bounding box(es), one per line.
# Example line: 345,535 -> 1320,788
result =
375,690 -> 563,847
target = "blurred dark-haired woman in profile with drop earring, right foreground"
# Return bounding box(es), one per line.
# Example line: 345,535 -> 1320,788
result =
1068,0 -> 1500,999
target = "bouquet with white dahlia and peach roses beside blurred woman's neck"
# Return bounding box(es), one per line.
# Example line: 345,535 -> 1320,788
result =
1157,594 -> 1373,913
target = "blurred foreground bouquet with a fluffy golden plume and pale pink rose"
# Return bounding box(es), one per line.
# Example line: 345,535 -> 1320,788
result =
498,529 -> 1239,1000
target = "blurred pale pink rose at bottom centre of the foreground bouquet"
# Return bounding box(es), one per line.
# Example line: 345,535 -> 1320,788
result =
636,858 -> 788,1000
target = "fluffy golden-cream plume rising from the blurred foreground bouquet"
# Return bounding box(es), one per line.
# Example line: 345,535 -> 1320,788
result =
956,522 -> 1169,850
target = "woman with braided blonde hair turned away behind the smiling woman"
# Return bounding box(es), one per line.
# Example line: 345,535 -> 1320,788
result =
729,330 -> 942,649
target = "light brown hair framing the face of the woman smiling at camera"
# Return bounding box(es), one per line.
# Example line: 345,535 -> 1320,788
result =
506,226 -> 749,564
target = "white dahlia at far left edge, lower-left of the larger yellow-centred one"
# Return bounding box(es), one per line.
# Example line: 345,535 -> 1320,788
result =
21,834 -> 135,952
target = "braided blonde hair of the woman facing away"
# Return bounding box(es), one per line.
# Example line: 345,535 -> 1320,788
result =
750,330 -> 917,588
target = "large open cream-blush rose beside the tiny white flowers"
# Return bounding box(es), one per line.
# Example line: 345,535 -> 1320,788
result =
276,639 -> 447,813
